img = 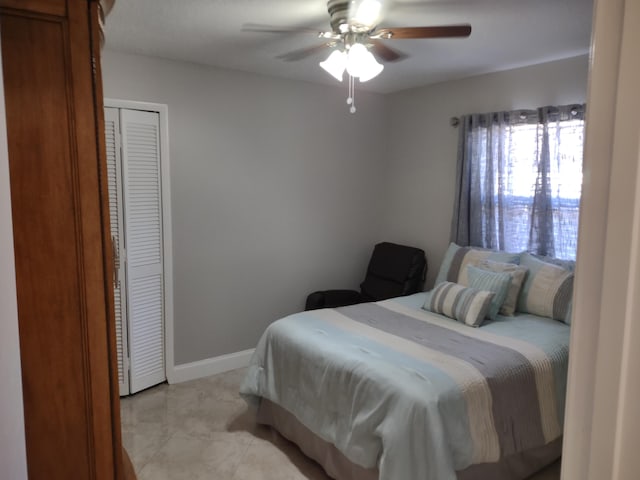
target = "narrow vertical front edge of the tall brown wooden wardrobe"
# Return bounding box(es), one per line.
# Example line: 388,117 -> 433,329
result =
67,1 -> 119,479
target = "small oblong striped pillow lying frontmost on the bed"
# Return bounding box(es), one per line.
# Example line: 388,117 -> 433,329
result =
422,282 -> 495,327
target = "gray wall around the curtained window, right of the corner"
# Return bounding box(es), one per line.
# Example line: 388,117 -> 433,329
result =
383,56 -> 588,287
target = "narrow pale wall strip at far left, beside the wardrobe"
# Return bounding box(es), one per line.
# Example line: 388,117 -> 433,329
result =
0,37 -> 27,480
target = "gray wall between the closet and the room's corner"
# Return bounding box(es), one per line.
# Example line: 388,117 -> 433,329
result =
103,51 -> 386,364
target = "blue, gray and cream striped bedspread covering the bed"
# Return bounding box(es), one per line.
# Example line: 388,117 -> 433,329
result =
241,293 -> 569,480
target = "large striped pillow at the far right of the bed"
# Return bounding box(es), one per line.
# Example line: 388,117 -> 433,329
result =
518,252 -> 573,322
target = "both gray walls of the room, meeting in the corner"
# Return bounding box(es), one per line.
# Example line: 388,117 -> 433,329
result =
103,51 -> 588,364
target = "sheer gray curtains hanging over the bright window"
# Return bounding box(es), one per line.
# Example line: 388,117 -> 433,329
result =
451,105 -> 585,259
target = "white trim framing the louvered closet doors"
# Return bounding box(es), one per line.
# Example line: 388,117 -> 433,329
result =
104,98 -> 175,383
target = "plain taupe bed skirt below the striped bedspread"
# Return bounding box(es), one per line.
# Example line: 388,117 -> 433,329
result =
257,398 -> 562,480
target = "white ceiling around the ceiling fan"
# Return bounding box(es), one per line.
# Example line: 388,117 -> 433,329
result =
101,0 -> 592,93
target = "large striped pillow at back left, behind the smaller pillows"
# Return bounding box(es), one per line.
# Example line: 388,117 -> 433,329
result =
435,242 -> 520,285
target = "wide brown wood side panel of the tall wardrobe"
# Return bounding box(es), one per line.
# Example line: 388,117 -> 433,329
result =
1,15 -> 90,478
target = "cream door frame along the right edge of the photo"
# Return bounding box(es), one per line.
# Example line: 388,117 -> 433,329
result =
562,0 -> 640,480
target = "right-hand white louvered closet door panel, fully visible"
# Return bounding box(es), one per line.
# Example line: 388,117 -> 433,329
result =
120,109 -> 165,393
